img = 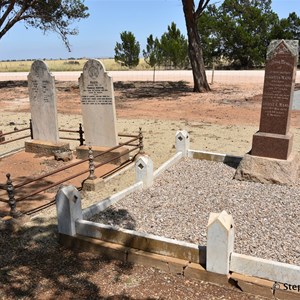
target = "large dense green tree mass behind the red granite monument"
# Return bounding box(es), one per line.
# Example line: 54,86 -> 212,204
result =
198,0 -> 300,69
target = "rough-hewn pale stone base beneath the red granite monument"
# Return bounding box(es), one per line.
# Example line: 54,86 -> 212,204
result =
234,153 -> 300,185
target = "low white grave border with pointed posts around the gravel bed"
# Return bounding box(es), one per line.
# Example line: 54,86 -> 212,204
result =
56,131 -> 300,300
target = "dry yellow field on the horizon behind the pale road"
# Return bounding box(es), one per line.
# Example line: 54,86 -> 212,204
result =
0,58 -> 150,72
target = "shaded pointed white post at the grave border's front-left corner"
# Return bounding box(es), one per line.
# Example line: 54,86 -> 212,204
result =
55,185 -> 82,236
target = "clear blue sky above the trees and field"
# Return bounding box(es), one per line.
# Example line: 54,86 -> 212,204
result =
0,0 -> 300,60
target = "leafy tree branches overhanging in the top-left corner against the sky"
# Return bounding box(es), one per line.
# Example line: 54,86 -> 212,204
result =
0,0 -> 89,50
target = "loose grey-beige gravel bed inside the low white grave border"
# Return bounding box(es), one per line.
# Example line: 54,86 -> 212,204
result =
92,159 -> 300,265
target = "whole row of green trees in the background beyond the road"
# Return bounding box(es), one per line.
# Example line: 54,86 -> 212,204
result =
115,0 -> 300,69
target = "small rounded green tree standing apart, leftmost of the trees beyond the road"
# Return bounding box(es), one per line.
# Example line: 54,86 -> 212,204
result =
115,31 -> 140,68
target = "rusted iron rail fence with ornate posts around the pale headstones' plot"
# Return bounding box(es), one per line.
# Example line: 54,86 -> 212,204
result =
0,125 -> 144,217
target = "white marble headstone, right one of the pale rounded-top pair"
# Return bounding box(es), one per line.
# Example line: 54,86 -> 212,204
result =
79,59 -> 117,147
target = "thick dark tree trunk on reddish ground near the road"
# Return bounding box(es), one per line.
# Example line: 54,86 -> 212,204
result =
182,0 -> 210,93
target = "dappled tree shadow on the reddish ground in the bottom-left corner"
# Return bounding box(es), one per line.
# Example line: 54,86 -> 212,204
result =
0,218 -> 150,299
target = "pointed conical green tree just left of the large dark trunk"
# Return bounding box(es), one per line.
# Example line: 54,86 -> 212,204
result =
158,22 -> 189,68
